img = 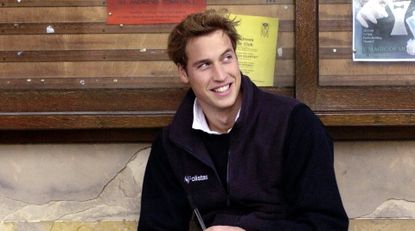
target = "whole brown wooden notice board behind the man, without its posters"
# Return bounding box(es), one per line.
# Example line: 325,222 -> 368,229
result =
0,0 -> 415,137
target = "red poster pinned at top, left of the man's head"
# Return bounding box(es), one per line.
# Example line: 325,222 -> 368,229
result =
107,0 -> 206,24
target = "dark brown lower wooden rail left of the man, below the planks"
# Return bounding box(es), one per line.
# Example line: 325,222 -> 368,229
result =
0,88 -> 186,130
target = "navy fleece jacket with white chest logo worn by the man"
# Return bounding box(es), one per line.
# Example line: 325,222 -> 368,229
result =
138,77 -> 348,231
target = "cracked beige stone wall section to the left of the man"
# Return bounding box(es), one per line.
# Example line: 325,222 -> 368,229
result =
0,144 -> 150,231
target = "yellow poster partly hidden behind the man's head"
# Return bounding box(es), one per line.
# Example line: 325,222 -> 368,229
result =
230,14 -> 278,86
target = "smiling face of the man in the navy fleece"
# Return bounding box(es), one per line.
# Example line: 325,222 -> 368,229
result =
179,30 -> 241,113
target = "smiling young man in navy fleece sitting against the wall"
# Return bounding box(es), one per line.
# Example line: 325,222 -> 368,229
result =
138,10 -> 348,231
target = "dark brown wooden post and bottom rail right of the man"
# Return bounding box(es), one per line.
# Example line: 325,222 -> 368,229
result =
296,0 -> 415,127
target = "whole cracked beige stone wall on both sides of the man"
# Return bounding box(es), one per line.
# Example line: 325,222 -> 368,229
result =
0,141 -> 415,231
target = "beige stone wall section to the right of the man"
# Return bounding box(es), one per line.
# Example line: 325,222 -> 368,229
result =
335,141 -> 415,231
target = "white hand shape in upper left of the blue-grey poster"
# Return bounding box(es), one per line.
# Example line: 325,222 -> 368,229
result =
356,0 -> 389,28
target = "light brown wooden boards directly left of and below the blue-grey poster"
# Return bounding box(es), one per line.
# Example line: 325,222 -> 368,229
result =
319,0 -> 415,86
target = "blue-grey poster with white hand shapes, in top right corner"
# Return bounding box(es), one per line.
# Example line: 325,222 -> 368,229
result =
353,0 -> 415,61
